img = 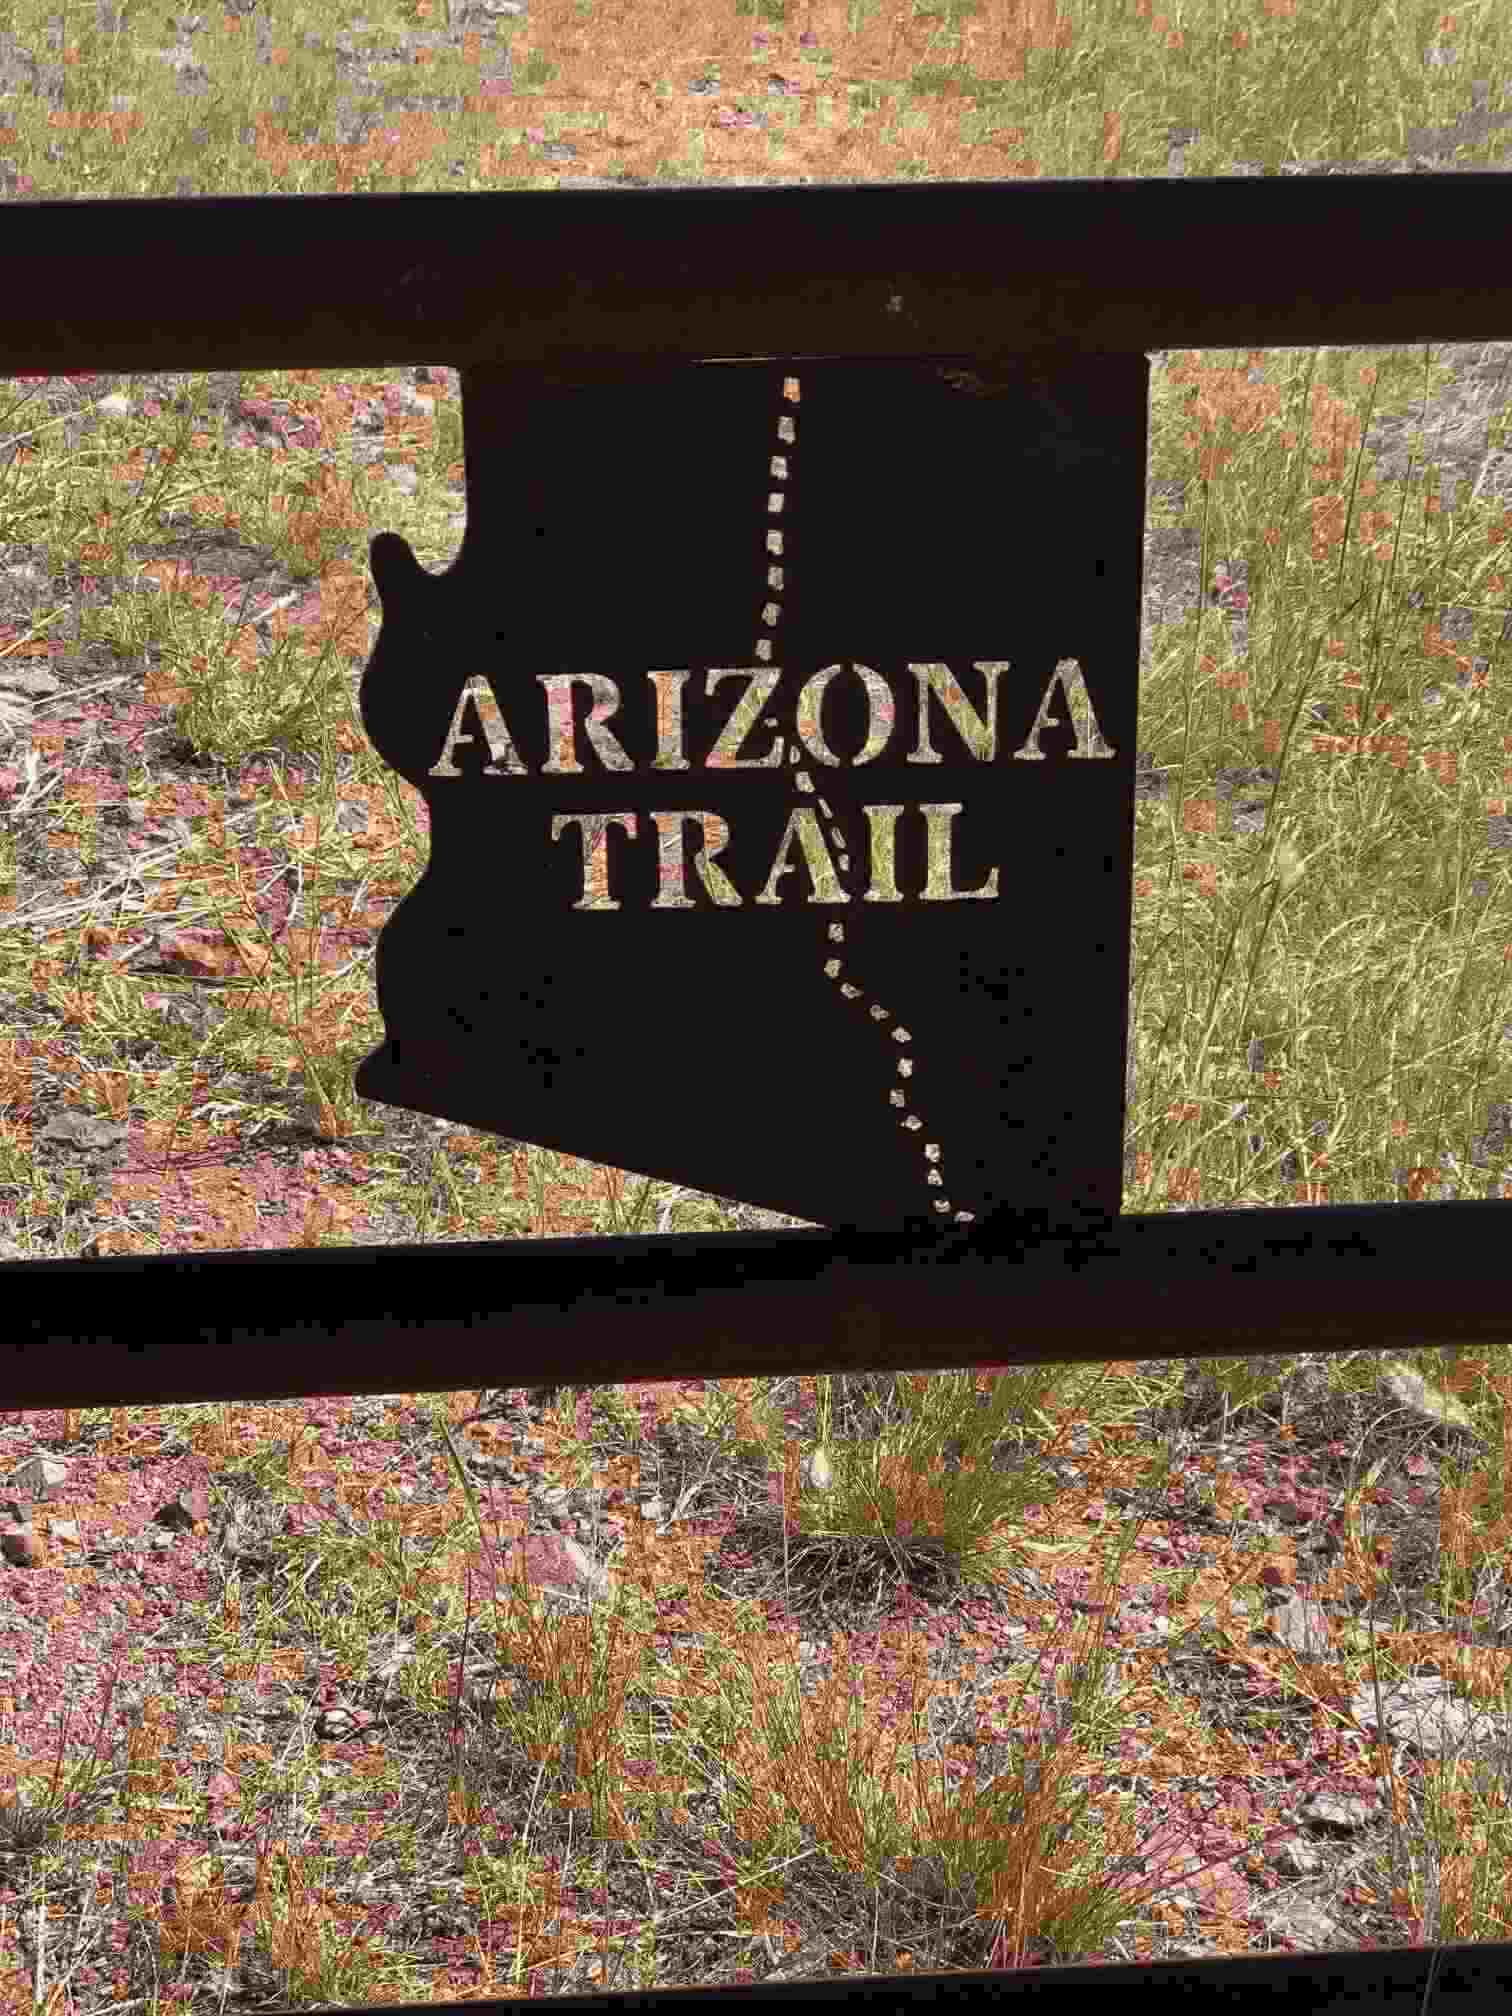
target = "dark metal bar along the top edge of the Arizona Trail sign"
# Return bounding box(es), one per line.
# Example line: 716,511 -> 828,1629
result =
0,169 -> 1512,375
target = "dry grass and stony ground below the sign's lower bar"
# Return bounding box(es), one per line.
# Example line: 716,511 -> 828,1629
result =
4,1353 -> 1512,2012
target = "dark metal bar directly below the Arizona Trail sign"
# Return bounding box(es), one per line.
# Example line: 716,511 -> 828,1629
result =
0,1204 -> 1512,1407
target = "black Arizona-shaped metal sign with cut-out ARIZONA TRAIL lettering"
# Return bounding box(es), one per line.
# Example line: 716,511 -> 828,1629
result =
357,357 -> 1147,1228
